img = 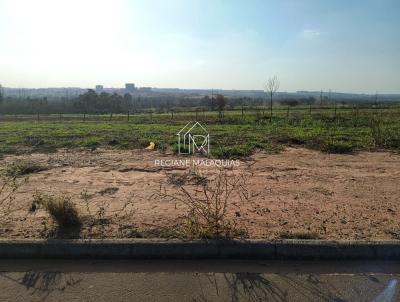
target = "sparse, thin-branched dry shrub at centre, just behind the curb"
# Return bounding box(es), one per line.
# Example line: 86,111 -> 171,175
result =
162,169 -> 249,239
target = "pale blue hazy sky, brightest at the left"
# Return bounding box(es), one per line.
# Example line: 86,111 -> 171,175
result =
0,0 -> 400,93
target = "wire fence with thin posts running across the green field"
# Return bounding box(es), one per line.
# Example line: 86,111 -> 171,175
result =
0,104 -> 400,123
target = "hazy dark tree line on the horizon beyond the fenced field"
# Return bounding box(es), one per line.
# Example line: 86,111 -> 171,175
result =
0,89 -> 382,114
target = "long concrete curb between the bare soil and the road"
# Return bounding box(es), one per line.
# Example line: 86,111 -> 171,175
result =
0,239 -> 400,260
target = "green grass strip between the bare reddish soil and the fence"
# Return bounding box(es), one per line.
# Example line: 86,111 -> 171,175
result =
0,109 -> 400,159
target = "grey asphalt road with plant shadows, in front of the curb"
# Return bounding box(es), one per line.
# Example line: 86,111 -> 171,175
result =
0,260 -> 400,302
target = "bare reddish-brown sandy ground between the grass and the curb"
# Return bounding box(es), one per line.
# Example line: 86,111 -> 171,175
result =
0,148 -> 400,240
